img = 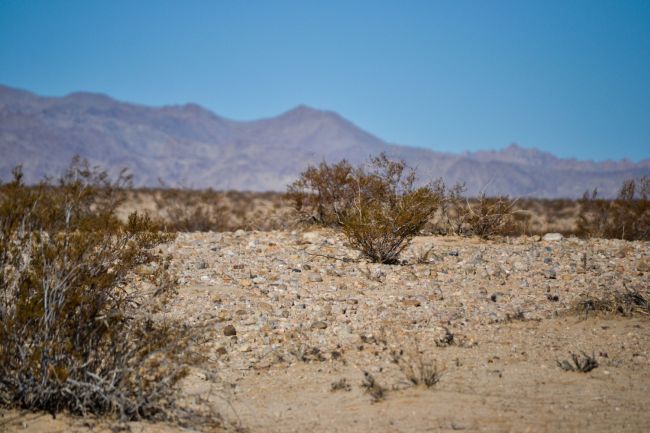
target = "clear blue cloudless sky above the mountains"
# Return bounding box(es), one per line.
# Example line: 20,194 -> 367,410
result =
0,0 -> 650,160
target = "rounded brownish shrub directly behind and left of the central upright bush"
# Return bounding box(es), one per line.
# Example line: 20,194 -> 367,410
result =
286,160 -> 358,226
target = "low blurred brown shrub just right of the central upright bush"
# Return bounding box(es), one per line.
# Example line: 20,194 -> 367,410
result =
443,183 -> 529,238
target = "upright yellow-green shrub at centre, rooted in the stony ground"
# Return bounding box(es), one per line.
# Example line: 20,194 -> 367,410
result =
341,154 -> 442,264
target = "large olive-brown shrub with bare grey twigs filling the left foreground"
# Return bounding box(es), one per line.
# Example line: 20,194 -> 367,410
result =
0,159 -> 188,420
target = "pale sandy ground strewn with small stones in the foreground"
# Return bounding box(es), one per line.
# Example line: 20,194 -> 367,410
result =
0,231 -> 650,432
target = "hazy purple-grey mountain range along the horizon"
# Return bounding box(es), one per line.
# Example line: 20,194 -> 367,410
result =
0,86 -> 650,197
